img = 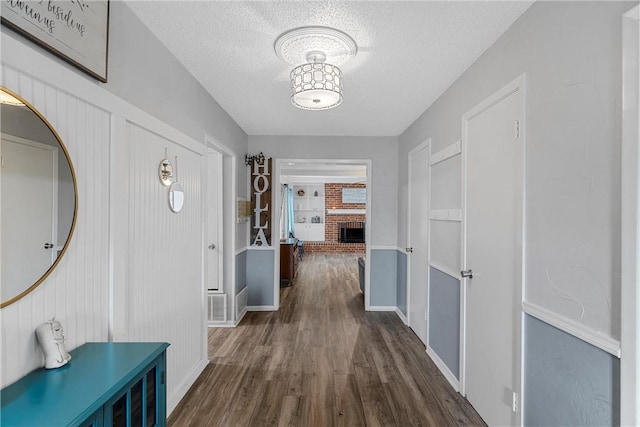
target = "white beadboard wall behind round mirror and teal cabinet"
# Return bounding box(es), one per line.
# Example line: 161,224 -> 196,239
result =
0,36 -> 208,413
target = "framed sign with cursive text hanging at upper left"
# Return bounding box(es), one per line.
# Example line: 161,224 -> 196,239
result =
0,0 -> 109,83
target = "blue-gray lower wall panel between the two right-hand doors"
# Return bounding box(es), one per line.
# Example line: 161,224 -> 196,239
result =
429,267 -> 460,379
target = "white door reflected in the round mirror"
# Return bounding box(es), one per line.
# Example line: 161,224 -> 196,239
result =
0,135 -> 58,301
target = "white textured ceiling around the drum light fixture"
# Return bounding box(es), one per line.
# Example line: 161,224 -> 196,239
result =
128,1 -> 532,136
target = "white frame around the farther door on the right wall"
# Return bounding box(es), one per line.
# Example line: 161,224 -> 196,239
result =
406,138 -> 431,338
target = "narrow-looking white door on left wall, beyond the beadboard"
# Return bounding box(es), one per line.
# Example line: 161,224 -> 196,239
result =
207,150 -> 223,291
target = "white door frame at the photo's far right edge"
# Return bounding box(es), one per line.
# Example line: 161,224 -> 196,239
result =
620,6 -> 640,425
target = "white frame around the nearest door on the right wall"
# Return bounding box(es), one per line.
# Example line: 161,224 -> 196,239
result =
460,73 -> 527,425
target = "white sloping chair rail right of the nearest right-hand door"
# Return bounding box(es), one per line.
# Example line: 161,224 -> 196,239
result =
522,301 -> 620,357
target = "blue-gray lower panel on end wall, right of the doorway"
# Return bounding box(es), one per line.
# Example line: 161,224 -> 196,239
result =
367,249 -> 398,307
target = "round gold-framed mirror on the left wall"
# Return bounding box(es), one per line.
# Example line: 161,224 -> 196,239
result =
0,86 -> 78,308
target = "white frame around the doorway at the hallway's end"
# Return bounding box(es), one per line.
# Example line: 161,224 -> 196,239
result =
271,158 -> 372,311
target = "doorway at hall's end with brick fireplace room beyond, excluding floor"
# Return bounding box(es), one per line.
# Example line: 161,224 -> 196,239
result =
273,159 -> 371,309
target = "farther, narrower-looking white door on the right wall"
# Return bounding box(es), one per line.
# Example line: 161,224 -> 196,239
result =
407,144 -> 429,345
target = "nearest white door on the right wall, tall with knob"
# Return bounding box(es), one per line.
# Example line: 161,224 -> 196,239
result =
463,79 -> 524,425
